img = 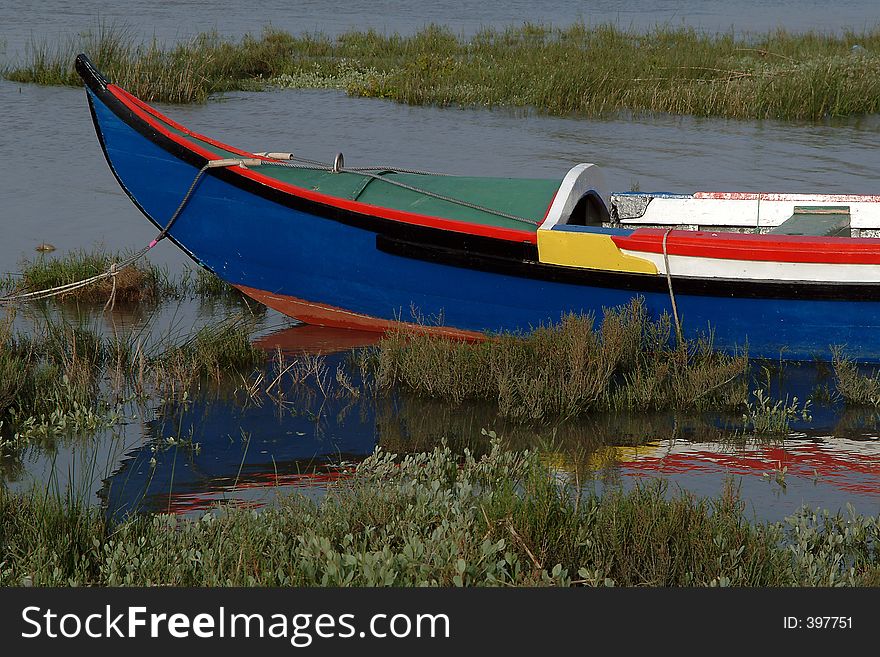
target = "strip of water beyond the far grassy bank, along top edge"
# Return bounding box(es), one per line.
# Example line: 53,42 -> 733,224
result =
0,0 -> 880,62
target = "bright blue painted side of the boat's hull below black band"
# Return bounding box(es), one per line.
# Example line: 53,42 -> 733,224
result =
88,84 -> 880,361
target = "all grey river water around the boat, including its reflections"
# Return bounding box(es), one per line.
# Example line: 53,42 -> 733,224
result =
0,0 -> 880,519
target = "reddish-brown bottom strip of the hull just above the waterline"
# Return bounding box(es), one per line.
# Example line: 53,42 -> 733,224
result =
235,285 -> 486,341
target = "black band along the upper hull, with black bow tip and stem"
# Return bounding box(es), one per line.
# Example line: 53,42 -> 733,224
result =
77,55 -> 880,301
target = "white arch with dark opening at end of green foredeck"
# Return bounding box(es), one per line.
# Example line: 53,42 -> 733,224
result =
540,163 -> 609,230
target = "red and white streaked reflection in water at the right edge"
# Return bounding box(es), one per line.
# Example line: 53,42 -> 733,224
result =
618,440 -> 880,495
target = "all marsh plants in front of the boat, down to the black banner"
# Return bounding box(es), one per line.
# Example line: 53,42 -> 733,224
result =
0,253 -> 880,587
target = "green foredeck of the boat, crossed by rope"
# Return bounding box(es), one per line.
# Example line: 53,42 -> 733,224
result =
160,116 -> 560,231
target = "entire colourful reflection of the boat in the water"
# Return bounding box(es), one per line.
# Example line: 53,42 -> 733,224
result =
102,325 -> 880,520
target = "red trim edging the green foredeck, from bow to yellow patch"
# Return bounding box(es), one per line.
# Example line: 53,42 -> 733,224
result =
107,84 -> 549,244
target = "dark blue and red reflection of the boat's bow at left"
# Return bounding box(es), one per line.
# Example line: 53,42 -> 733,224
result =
101,325 -> 378,519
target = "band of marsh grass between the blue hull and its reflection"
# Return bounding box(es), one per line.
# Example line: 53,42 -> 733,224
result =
0,251 -> 880,446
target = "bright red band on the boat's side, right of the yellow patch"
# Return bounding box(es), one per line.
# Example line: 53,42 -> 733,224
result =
611,228 -> 880,265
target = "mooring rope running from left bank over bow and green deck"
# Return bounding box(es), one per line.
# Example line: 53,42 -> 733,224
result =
0,153 -> 532,311
